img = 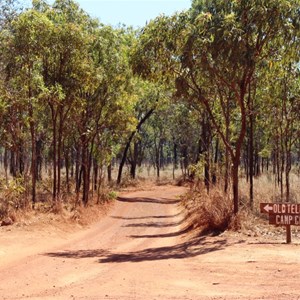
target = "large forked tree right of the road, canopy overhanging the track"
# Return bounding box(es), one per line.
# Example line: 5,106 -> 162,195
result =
136,0 -> 297,214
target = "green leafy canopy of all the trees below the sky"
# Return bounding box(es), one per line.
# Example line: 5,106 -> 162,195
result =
0,0 -> 300,213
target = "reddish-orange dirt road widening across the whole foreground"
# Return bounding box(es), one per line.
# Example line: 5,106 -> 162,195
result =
0,186 -> 300,300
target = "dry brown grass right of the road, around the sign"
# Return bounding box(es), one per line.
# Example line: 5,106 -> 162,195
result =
180,174 -> 300,238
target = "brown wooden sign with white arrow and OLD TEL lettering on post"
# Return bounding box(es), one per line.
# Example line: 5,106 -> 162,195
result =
260,203 -> 300,244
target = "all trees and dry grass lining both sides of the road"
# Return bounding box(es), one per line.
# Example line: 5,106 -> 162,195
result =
0,0 -> 300,231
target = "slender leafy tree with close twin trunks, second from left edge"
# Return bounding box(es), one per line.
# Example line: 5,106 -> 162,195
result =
28,0 -> 96,201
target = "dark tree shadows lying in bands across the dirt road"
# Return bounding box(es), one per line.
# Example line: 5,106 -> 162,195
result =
45,191 -> 246,263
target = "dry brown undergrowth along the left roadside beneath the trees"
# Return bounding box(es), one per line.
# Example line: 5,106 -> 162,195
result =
0,178 -> 117,226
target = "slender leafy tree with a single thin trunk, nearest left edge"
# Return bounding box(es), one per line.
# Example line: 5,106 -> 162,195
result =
7,10 -> 51,205
